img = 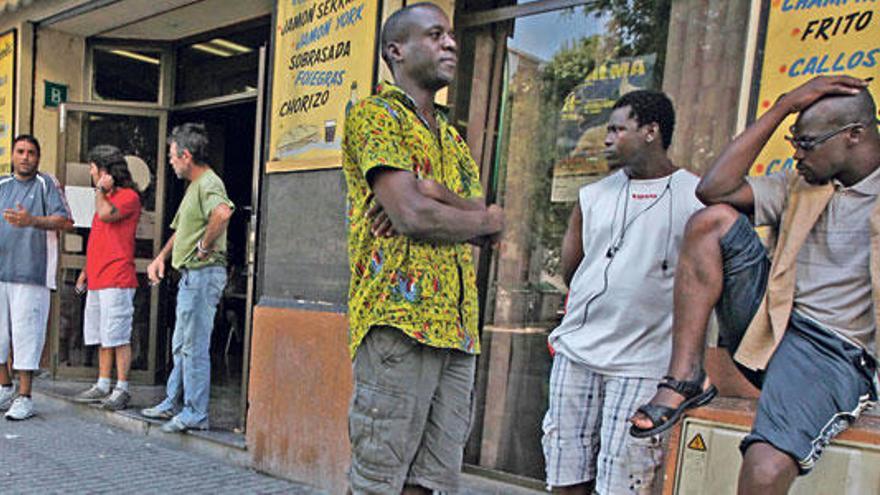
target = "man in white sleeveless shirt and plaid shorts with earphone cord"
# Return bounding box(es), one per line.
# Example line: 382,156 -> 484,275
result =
543,91 -> 702,494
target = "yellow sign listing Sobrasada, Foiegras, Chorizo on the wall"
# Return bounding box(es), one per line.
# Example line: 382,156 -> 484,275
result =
266,0 -> 379,173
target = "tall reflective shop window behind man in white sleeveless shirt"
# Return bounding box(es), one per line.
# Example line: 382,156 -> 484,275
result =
455,0 -> 669,480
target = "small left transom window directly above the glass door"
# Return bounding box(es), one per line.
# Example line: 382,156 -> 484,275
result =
92,47 -> 162,103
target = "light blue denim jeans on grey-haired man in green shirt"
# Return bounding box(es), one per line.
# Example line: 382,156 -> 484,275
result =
158,266 -> 226,426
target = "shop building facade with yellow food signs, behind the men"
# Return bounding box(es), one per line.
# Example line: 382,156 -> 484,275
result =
0,0 -> 880,493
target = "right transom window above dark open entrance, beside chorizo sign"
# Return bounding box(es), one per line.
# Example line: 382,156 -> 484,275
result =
174,24 -> 270,104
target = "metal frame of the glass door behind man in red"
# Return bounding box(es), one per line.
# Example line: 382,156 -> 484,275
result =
49,102 -> 168,385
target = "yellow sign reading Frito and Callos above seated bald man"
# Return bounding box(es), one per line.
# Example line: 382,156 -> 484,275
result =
751,0 -> 880,175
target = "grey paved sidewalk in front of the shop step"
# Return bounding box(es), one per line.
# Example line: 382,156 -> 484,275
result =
0,396 -> 322,495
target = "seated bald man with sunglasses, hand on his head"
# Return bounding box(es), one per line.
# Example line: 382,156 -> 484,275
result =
631,76 -> 880,494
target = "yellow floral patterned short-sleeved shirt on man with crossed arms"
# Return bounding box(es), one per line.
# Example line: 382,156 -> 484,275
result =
342,83 -> 483,359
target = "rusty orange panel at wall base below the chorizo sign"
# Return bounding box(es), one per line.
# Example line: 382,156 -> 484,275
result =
247,306 -> 352,493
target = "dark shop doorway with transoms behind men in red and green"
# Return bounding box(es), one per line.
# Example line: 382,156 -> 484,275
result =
50,5 -> 271,431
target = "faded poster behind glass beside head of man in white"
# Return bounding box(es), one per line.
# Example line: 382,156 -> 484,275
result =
550,54 -> 657,203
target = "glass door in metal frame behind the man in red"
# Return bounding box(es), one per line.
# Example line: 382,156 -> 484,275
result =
50,103 -> 170,384
